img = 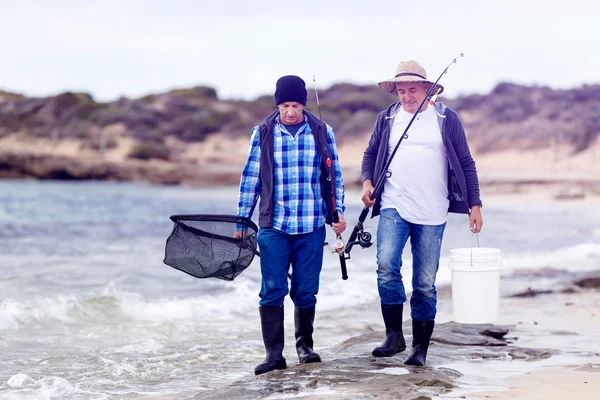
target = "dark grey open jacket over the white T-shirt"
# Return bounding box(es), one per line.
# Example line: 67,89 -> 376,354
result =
361,103 -> 481,217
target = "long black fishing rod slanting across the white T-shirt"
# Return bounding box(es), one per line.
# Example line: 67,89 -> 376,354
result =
344,53 -> 464,259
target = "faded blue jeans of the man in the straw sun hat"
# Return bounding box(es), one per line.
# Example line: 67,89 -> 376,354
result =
377,208 -> 446,321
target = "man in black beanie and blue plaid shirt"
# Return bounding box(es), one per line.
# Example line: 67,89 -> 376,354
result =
235,75 -> 346,375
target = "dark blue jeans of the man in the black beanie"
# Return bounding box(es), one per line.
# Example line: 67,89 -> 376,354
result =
258,226 -> 325,308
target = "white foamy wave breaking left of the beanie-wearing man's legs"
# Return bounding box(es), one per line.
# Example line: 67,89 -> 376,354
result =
0,282 -> 256,331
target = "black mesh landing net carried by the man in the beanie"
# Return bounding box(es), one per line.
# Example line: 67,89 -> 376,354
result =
164,215 -> 258,281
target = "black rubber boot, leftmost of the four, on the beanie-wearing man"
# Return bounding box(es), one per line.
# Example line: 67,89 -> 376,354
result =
254,306 -> 287,375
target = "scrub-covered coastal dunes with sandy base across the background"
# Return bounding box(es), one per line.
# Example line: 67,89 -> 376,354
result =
0,83 -> 600,197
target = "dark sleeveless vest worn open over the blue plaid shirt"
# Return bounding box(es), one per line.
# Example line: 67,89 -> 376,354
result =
258,110 -> 337,228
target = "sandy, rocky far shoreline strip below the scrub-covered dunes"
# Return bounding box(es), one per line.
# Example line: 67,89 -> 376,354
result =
0,134 -> 600,200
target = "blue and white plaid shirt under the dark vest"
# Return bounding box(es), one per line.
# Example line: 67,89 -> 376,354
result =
237,117 -> 345,235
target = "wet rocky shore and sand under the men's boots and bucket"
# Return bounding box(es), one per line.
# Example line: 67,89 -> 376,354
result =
194,269 -> 600,400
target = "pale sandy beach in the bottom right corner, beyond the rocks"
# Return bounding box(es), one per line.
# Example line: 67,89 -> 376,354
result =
439,275 -> 600,400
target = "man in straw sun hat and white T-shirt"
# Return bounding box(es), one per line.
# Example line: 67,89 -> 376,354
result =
361,60 -> 483,366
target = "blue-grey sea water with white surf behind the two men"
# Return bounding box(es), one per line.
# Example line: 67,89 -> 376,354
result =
0,181 -> 600,399
